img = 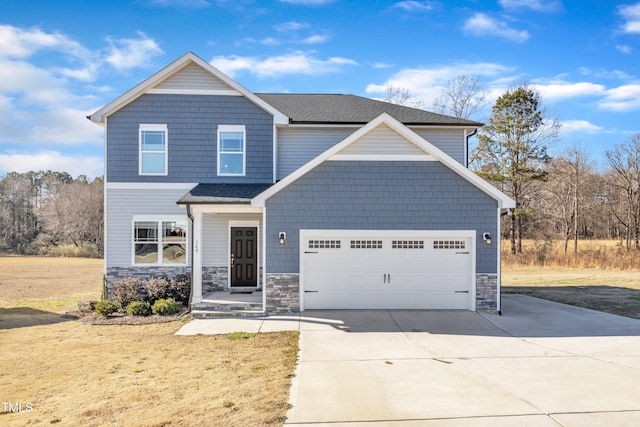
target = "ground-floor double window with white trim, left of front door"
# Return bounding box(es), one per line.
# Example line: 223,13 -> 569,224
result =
133,218 -> 187,265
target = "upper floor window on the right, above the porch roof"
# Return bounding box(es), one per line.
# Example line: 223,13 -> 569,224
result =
218,125 -> 246,176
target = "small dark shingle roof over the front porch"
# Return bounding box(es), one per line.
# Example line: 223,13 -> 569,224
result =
178,184 -> 273,205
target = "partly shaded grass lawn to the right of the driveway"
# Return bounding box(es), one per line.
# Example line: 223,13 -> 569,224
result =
502,265 -> 640,319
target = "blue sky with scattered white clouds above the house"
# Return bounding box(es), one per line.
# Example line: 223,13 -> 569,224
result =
0,0 -> 640,177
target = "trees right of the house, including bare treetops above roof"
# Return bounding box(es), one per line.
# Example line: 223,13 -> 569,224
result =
392,76 -> 640,254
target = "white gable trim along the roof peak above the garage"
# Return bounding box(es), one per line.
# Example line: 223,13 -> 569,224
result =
251,113 -> 515,208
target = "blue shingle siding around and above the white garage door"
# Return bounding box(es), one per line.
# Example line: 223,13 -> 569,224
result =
266,161 -> 498,273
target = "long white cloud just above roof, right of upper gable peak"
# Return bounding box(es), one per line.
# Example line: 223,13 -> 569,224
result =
211,51 -> 357,78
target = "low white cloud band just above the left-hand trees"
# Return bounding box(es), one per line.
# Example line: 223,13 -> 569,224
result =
0,150 -> 104,178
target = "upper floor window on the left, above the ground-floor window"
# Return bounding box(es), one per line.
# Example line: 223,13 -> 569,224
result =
140,124 -> 168,175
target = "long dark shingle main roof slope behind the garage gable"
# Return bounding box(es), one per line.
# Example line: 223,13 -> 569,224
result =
256,93 -> 482,128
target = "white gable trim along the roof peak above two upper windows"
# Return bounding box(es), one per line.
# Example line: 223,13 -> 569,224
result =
87,52 -> 289,124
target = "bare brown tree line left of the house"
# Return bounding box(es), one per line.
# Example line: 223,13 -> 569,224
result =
0,171 -> 104,256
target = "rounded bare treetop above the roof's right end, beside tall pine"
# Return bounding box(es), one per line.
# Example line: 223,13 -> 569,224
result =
433,75 -> 489,119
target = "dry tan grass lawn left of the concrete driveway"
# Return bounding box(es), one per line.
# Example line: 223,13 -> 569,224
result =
0,257 -> 298,426
